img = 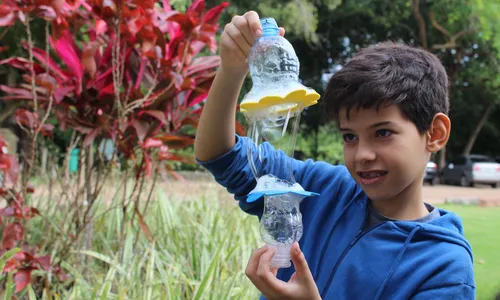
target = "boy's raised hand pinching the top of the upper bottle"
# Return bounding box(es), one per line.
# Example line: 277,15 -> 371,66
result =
220,11 -> 285,74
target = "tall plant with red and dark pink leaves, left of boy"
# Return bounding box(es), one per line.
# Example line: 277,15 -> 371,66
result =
0,0 -> 230,296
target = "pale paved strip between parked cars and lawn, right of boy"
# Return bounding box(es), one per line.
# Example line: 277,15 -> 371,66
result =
424,185 -> 500,206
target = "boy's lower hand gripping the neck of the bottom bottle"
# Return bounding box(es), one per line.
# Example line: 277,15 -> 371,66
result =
245,243 -> 321,300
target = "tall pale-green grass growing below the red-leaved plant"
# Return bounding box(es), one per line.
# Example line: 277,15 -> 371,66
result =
0,193 -> 261,300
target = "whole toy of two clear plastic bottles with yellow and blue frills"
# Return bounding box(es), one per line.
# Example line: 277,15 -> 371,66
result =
241,18 -> 319,268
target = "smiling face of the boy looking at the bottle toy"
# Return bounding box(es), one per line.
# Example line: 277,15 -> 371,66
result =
339,105 -> 429,201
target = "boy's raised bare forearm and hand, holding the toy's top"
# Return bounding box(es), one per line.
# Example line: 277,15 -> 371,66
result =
194,11 -> 284,161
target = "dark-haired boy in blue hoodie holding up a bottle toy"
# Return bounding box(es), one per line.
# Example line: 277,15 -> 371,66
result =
195,12 -> 475,299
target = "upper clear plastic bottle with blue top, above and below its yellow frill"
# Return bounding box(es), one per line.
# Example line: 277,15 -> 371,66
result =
243,18 -> 305,182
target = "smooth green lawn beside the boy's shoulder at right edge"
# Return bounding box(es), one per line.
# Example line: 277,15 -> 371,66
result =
439,205 -> 500,300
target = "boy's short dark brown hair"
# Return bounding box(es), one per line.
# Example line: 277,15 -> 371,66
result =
323,42 -> 450,134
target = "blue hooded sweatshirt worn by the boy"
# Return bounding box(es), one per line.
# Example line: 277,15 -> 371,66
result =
199,136 -> 475,300
